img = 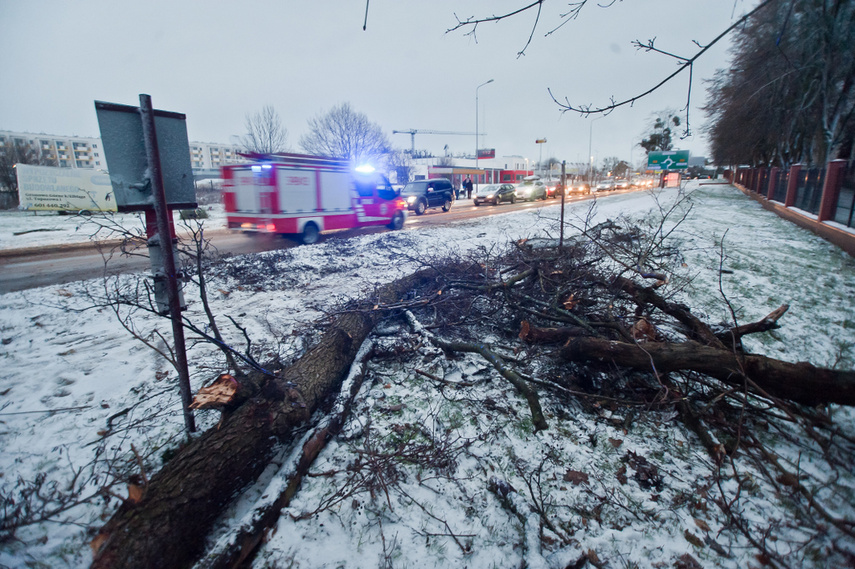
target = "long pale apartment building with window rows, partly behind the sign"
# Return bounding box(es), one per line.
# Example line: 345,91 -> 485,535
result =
0,130 -> 245,173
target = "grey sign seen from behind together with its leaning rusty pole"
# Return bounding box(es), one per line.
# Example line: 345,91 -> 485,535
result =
95,94 -> 196,433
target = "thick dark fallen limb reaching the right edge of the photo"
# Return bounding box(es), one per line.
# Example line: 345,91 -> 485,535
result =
561,338 -> 855,405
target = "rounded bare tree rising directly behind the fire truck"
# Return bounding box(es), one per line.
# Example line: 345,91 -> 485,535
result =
300,103 -> 391,163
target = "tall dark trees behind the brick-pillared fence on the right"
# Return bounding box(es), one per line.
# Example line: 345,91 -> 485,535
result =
706,0 -> 855,167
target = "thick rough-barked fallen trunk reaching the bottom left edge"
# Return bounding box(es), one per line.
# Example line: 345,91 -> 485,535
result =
92,271 -> 438,569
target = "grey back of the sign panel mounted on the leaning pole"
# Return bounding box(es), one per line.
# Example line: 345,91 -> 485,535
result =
95,101 -> 196,211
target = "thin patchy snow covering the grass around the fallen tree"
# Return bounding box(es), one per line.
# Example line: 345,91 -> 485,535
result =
0,184 -> 855,568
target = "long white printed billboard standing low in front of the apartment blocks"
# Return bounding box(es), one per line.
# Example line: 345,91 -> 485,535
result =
15,164 -> 116,211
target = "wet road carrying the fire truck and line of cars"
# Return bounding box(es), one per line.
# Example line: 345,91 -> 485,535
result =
0,192 -> 614,294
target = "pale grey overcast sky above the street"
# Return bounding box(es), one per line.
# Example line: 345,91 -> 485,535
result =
0,0 -> 757,170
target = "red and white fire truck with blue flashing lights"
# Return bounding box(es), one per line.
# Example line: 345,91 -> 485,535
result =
222,153 -> 407,244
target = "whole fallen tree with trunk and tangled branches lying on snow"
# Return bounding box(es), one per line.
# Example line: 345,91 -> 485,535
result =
93,215 -> 855,568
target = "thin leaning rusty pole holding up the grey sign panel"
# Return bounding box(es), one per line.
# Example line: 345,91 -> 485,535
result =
140,94 -> 196,433
